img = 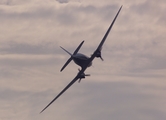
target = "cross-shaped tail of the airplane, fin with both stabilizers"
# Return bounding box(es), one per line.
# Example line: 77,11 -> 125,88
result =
60,41 -> 84,72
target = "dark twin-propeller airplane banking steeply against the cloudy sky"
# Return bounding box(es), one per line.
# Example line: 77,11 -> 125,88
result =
40,6 -> 122,113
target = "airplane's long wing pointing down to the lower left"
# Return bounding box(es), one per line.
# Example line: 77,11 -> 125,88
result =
40,68 -> 86,113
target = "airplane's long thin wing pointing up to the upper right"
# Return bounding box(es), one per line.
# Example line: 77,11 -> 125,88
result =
94,6 -> 122,59
